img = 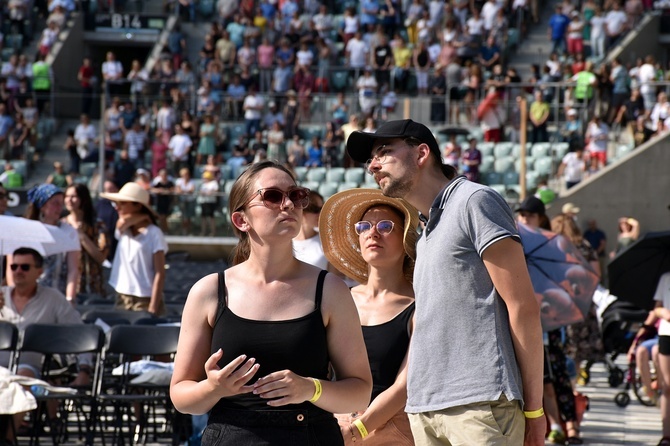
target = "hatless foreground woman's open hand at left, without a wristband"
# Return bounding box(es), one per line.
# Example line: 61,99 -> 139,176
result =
205,349 -> 260,398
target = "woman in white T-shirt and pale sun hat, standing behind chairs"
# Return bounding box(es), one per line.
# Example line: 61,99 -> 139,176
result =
100,183 -> 168,316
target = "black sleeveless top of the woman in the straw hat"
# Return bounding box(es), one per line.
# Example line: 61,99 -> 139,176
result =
363,302 -> 414,400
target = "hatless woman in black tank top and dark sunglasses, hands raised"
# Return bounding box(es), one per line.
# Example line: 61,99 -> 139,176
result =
170,161 -> 372,446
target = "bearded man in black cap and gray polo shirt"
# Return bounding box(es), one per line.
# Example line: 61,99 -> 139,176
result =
347,120 -> 546,446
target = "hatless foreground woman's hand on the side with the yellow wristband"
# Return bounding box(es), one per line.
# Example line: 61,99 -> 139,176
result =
253,370 -> 315,407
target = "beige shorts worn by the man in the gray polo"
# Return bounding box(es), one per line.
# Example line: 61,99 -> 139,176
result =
409,395 -> 526,446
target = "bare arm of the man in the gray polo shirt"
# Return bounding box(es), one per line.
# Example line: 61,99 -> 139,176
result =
482,237 -> 546,446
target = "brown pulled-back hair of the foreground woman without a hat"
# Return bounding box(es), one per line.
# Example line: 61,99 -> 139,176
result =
228,161 -> 295,265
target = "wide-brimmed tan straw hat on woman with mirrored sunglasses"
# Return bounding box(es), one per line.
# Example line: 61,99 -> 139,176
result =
319,189 -> 419,283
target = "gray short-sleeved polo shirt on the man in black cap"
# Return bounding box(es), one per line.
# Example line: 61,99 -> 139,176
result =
406,177 -> 523,413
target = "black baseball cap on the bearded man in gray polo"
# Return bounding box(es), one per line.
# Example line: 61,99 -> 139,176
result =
347,119 -> 442,163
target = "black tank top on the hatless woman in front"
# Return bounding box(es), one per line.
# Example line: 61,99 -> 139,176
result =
211,271 -> 330,415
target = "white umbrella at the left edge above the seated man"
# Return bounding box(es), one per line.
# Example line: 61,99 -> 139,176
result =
0,221 -> 81,256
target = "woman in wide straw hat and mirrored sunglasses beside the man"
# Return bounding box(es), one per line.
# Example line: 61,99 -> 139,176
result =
319,189 -> 419,446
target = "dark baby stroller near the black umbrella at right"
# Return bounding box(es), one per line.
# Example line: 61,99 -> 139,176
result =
601,300 -> 649,407
